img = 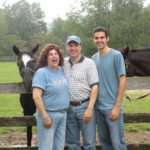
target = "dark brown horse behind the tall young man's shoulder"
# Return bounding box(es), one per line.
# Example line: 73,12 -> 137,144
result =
120,47 -> 150,77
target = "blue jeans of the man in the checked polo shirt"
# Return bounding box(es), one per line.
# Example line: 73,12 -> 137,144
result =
66,101 -> 96,150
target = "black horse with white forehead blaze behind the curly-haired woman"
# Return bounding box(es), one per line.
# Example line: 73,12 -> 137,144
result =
13,45 -> 39,146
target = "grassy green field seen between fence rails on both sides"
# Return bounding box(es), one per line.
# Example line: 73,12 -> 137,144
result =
0,62 -> 150,133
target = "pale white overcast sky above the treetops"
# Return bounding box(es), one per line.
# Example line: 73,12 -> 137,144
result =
0,0 -> 150,22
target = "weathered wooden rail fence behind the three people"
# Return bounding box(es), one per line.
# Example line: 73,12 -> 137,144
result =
0,77 -> 150,150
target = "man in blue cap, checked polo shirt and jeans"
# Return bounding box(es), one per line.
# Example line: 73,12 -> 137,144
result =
64,35 -> 99,150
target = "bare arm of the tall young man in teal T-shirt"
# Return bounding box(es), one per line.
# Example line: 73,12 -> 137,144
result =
110,75 -> 126,120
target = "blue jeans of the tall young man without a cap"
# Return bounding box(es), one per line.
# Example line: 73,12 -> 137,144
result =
96,110 -> 127,150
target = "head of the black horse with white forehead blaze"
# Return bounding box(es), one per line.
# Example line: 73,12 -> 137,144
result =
13,44 -> 39,92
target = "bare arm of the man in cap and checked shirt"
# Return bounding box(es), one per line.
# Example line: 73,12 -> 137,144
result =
84,84 -> 98,123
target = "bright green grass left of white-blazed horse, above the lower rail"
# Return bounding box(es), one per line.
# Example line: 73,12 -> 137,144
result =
0,62 -> 22,116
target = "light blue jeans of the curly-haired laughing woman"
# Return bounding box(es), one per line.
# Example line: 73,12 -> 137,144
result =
36,111 -> 67,150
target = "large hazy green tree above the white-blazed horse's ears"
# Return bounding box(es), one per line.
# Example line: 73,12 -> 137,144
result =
0,0 -> 46,56
